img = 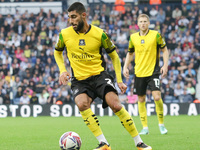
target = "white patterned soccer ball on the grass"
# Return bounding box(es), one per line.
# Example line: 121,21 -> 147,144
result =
59,131 -> 82,150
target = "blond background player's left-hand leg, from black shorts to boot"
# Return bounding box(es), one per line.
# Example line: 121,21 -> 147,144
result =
134,76 -> 149,135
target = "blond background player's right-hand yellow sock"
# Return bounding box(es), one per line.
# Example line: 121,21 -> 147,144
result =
155,99 -> 164,124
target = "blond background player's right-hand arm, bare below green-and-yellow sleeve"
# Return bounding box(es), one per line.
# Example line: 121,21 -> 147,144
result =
157,33 -> 169,77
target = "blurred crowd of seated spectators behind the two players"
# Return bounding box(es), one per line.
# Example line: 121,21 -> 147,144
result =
0,4 -> 200,104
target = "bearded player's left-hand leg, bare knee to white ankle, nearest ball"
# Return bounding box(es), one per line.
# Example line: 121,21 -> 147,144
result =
75,93 -> 108,143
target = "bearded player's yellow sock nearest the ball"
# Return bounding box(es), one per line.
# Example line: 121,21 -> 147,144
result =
80,108 -> 103,137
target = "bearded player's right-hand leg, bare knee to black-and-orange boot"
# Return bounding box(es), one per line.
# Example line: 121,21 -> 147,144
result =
105,91 -> 151,150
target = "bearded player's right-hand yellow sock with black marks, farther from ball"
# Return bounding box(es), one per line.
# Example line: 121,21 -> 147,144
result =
115,107 -> 138,137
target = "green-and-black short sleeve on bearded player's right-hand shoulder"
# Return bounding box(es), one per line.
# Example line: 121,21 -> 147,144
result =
101,31 -> 116,54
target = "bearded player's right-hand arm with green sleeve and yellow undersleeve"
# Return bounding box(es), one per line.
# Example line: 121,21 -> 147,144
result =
101,32 -> 127,93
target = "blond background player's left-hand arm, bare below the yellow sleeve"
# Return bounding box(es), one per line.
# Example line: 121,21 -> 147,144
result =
123,38 -> 135,78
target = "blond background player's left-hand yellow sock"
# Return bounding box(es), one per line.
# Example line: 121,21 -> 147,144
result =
138,101 -> 147,128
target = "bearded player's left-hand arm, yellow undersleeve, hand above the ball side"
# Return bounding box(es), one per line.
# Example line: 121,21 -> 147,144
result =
54,33 -> 70,85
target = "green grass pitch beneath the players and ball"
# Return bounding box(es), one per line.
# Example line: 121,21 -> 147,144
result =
0,115 -> 200,150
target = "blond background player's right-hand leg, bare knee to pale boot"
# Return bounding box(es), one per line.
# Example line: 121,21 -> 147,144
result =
152,91 -> 167,134
